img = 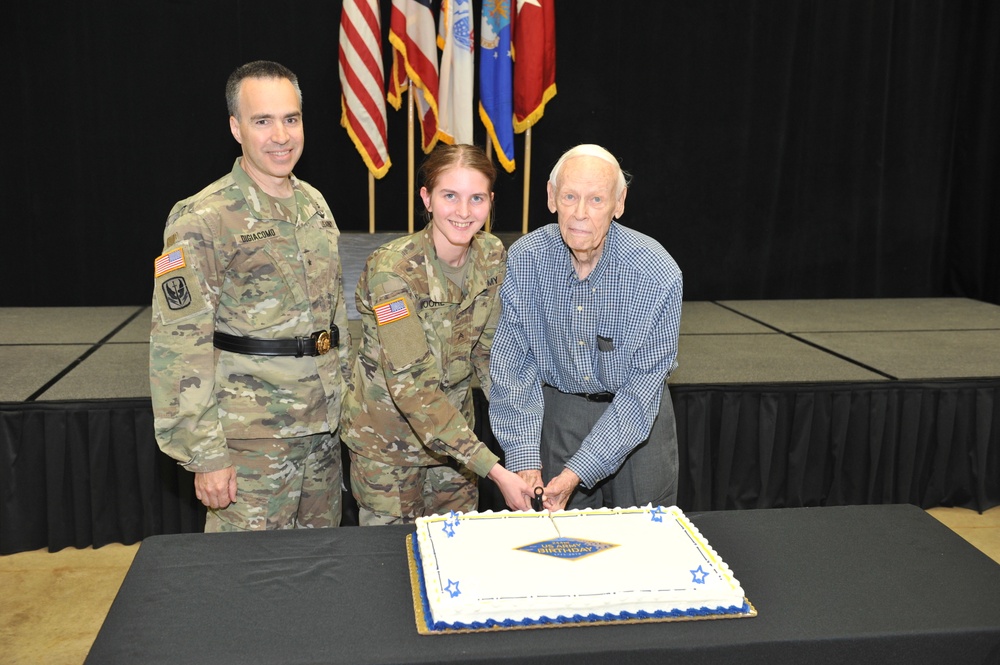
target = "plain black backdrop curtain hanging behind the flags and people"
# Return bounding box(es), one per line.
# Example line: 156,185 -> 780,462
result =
0,0 -> 1000,306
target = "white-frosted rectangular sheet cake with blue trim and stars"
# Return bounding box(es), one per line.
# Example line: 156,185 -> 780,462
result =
414,506 -> 752,630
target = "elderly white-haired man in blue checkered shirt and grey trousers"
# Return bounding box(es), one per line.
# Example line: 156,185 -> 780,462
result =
490,144 -> 682,510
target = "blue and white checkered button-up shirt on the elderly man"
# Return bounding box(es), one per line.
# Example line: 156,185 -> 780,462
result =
490,222 -> 683,487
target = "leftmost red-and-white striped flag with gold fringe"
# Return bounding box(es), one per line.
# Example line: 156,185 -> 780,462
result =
339,0 -> 392,178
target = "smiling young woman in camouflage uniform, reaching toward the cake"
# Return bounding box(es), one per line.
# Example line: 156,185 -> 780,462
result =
341,145 -> 530,526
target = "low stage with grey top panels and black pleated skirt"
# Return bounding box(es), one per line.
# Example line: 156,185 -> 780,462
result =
0,234 -> 1000,554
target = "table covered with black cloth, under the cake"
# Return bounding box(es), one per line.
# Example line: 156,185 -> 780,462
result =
86,505 -> 1000,665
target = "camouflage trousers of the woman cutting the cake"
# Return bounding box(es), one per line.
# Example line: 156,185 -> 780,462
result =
351,450 -> 479,526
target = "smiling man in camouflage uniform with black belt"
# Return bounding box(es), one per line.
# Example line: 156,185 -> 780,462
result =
150,61 -> 350,531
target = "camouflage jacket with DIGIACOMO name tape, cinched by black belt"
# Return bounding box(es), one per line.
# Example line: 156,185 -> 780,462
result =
149,159 -> 351,471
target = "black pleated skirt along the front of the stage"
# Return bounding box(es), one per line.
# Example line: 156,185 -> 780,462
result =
0,380 -> 1000,555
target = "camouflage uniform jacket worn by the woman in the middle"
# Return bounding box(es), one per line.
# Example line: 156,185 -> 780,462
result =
341,226 -> 507,476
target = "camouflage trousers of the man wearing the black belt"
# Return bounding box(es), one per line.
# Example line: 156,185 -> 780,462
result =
205,433 -> 342,532
